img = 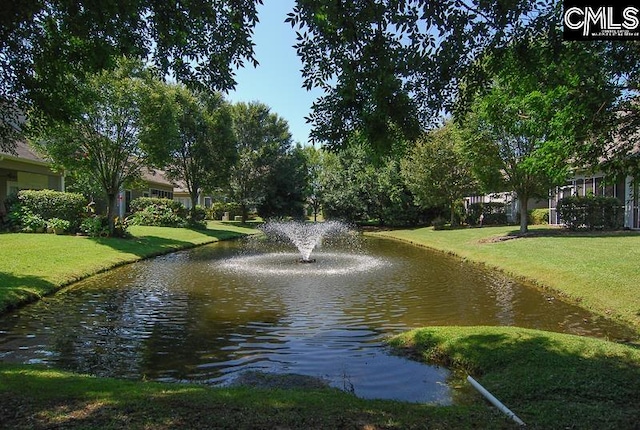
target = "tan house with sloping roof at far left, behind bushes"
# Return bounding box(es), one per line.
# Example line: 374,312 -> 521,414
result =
0,141 -> 65,215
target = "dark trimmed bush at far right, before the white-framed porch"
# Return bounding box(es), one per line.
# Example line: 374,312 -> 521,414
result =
556,196 -> 624,230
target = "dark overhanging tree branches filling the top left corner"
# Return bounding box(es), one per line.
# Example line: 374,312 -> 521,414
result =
0,0 -> 262,148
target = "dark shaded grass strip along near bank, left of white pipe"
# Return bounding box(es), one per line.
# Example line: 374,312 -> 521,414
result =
0,365 -> 500,429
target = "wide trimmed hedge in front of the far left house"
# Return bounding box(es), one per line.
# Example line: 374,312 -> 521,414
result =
7,190 -> 87,231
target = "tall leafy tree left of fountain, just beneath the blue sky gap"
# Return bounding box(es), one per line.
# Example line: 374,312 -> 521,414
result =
229,102 -> 291,222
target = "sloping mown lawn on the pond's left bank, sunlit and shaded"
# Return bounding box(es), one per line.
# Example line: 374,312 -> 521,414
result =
0,222 -> 255,313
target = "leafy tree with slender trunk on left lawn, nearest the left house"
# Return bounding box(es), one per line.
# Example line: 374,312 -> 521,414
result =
31,59 -> 164,234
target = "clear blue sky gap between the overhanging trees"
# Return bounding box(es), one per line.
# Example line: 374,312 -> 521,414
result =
227,0 -> 321,145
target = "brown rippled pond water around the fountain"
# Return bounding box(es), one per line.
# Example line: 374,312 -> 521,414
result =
0,238 -> 631,404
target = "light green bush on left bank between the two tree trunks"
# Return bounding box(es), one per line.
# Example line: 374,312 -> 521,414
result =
127,197 -> 188,227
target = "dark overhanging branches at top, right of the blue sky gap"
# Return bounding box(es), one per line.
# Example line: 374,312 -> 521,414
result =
287,0 -> 561,152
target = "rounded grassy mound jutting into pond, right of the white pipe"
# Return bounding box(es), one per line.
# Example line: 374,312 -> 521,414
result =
391,327 -> 640,429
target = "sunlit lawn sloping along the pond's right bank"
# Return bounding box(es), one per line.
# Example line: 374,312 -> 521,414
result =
372,227 -> 640,333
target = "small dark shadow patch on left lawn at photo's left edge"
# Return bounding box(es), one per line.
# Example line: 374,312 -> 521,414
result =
0,272 -> 58,314
